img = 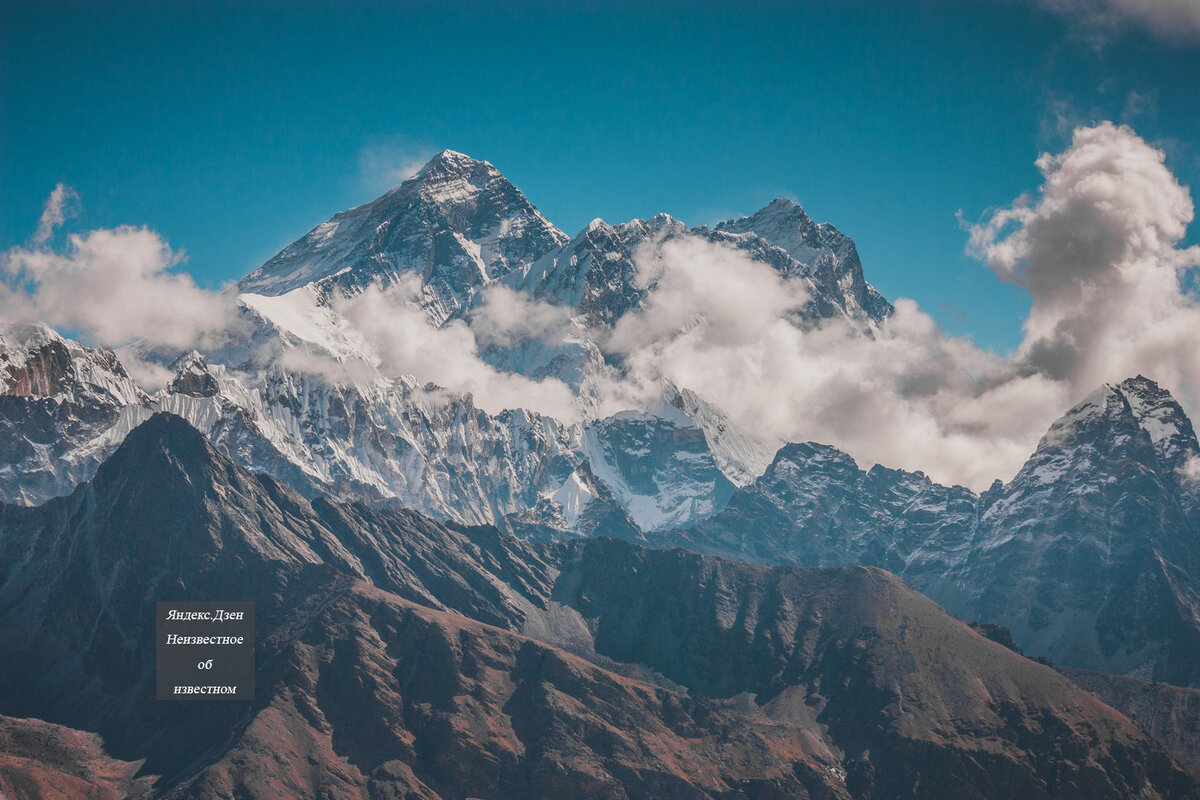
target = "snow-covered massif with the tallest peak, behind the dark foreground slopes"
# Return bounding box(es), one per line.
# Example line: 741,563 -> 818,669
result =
0,150 -> 931,530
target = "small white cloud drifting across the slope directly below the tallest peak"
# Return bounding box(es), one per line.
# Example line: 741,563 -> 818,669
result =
334,275 -> 577,421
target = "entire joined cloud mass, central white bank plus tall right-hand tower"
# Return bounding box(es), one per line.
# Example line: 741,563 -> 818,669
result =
583,124 -> 1200,489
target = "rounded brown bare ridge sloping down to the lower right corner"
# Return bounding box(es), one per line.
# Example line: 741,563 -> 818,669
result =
556,540 -> 1190,798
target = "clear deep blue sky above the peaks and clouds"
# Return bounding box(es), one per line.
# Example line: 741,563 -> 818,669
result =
0,0 -> 1200,351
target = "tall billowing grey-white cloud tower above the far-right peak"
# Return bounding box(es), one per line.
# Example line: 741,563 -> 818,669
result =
968,122 -> 1200,403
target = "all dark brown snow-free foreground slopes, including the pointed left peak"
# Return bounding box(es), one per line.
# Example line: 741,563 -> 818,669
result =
0,415 -> 1198,800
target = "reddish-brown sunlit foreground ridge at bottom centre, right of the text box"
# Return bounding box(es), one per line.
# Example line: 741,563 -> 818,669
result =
170,583 -> 864,800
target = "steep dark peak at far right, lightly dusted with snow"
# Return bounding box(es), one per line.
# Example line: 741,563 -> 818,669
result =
945,378 -> 1200,685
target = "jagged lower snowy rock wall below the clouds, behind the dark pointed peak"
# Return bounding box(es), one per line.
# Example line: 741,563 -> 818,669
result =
0,319 -> 748,533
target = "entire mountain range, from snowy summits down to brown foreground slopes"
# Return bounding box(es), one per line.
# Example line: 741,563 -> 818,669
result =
0,151 -> 1200,798
